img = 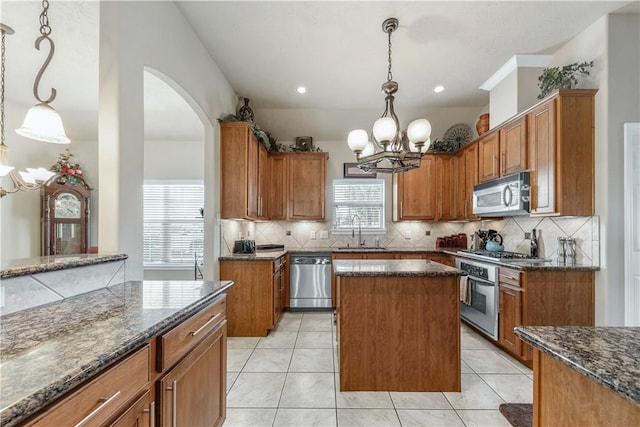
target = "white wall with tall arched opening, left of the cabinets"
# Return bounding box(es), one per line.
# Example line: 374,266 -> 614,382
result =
99,2 -> 236,280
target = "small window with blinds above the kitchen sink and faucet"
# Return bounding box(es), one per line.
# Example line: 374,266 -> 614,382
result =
332,179 -> 386,234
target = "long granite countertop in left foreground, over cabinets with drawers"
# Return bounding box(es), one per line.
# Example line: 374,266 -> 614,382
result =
0,281 -> 233,427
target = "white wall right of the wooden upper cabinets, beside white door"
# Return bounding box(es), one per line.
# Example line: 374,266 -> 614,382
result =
550,14 -> 640,326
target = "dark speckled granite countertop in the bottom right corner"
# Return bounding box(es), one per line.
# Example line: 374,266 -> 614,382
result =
515,326 -> 640,405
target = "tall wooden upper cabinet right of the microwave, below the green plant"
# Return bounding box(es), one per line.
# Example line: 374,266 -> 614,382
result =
526,89 -> 597,216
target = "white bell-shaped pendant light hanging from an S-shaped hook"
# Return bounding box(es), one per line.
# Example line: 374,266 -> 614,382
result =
16,0 -> 71,144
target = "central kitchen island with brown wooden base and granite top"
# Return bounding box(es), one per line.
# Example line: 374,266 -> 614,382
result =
333,259 -> 465,391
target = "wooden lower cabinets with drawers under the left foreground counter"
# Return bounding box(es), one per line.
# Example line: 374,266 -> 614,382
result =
24,295 -> 227,427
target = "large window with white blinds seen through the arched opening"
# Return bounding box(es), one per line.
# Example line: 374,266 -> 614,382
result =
144,180 -> 204,268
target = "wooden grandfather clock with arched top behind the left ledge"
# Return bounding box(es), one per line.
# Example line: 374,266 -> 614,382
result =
41,178 -> 92,256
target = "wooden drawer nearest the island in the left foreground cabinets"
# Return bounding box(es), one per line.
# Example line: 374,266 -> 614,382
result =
157,295 -> 227,372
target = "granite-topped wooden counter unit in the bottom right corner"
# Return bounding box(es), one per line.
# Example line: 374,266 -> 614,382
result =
515,326 -> 640,426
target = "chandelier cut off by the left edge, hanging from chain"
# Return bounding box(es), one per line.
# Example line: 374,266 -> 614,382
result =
0,23 -> 55,197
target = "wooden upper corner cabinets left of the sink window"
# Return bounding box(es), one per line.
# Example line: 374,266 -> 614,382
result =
220,122 -> 329,221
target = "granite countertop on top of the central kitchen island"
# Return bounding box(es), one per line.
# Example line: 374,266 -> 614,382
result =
333,259 -> 466,277
